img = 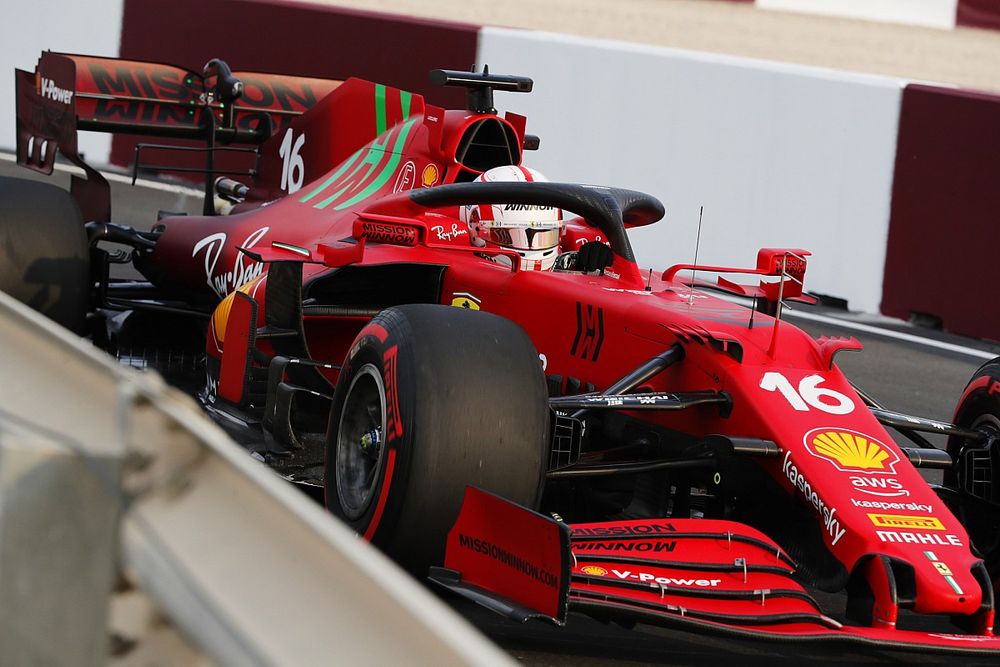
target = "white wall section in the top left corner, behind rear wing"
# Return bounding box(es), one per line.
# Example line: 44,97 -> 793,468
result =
0,0 -> 123,164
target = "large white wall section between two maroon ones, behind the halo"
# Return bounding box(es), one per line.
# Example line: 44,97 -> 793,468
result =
478,28 -> 902,312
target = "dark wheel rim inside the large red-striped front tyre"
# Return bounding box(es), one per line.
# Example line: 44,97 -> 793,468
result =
335,364 -> 385,521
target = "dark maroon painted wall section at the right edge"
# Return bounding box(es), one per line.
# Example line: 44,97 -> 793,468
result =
882,85 -> 1000,340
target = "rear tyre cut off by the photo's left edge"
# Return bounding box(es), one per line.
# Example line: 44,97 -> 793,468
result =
0,178 -> 90,333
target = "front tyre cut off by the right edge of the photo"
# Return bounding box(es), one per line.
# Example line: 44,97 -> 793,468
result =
944,357 -> 1000,576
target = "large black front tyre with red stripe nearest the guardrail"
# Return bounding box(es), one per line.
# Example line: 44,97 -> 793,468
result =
325,305 -> 549,577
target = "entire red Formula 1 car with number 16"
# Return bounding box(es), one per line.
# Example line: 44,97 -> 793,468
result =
0,53 -> 1000,652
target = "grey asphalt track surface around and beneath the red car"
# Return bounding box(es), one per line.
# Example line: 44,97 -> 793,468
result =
7,155 -> 1000,666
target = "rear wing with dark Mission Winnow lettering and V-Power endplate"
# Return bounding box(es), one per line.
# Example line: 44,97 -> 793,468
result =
15,51 -> 341,219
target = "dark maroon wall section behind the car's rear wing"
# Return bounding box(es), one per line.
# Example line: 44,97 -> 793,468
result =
111,0 -> 480,170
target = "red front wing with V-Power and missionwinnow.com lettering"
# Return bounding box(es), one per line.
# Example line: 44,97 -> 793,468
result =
430,487 -> 1000,653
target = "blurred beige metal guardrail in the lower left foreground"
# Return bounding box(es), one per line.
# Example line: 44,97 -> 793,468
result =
0,293 -> 510,665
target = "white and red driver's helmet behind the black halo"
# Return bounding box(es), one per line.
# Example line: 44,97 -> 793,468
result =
459,165 -> 566,271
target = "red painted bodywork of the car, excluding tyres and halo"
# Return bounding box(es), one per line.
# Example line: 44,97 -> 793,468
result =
19,56 -> 1000,650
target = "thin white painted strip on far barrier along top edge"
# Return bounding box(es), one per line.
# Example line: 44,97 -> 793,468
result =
756,0 -> 958,29
